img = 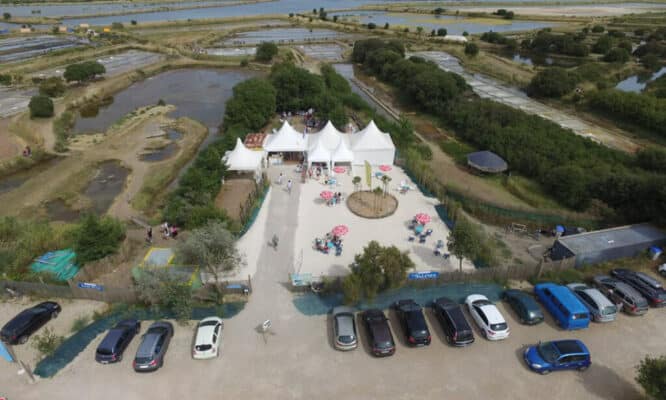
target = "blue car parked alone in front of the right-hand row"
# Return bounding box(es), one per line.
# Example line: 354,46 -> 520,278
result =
523,340 -> 592,375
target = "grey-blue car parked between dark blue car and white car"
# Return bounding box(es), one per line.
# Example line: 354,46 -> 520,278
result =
133,321 -> 173,372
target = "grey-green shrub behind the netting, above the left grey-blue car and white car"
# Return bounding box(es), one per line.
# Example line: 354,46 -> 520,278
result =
135,268 -> 192,321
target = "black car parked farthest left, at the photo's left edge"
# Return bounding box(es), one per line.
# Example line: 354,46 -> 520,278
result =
0,301 -> 62,344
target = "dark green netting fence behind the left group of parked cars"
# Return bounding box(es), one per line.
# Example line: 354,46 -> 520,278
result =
35,302 -> 245,378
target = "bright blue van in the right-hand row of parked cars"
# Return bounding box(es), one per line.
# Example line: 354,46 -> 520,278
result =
534,283 -> 590,330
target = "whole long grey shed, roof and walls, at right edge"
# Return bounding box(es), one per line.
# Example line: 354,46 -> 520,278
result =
550,224 -> 666,267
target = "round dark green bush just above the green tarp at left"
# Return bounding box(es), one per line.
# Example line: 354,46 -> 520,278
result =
72,213 -> 125,265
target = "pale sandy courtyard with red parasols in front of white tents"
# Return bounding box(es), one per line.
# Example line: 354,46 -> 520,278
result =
294,166 -> 474,278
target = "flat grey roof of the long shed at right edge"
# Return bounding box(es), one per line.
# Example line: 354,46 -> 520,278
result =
558,224 -> 666,254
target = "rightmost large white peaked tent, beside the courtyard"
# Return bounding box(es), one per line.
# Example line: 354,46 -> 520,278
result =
351,121 -> 395,165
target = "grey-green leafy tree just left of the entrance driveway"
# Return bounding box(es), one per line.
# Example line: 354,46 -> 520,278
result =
176,221 -> 243,300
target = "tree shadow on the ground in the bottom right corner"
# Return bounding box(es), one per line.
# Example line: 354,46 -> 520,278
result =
578,362 -> 643,400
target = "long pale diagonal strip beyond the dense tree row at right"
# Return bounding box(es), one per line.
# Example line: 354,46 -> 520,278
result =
410,51 -> 639,151
